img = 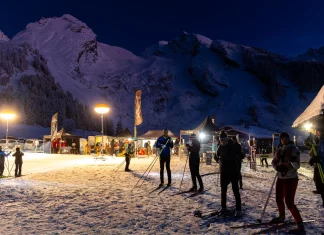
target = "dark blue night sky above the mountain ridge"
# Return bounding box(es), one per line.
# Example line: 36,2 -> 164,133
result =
0,0 -> 324,56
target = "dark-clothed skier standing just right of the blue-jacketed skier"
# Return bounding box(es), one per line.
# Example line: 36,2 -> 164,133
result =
186,134 -> 204,192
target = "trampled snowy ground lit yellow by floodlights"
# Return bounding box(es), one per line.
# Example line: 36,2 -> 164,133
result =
0,153 -> 324,234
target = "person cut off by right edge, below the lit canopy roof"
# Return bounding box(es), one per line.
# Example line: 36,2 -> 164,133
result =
309,128 -> 324,208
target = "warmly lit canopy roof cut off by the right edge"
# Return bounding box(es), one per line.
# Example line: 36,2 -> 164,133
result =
292,86 -> 324,127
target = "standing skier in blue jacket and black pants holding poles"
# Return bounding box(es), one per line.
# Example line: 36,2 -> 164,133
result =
156,129 -> 173,187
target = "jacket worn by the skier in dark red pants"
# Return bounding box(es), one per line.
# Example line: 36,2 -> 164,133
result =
272,141 -> 300,179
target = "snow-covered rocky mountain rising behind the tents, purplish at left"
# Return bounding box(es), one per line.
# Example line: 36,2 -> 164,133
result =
1,15 -> 322,135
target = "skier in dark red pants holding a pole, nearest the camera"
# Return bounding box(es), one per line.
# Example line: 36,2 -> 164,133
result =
272,132 -> 305,233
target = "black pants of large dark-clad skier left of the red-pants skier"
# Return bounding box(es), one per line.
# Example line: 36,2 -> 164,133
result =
220,172 -> 242,211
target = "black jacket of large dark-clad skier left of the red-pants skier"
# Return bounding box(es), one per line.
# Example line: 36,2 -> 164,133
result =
215,140 -> 240,177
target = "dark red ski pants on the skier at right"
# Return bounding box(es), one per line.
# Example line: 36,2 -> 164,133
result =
276,178 -> 303,223
